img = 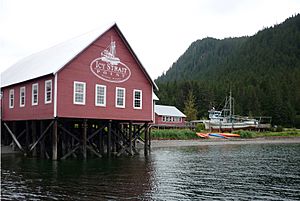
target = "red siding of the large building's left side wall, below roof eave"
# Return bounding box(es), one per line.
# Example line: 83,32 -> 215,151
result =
2,76 -> 54,121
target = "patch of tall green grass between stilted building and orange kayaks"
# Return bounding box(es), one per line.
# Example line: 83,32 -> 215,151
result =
151,129 -> 197,140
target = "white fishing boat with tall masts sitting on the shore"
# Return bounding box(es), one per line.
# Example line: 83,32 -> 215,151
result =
203,92 -> 259,131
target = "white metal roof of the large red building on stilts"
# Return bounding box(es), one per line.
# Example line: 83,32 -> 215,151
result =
1,23 -> 157,88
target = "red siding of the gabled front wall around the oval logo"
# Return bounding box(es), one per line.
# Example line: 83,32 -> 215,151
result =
57,27 -> 153,121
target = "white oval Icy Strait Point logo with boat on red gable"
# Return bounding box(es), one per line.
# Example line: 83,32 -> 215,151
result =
90,40 -> 131,83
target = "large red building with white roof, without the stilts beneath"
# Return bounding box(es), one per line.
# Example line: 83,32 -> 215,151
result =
1,24 -> 157,159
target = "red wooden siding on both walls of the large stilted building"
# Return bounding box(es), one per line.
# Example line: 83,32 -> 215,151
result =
2,26 -> 154,122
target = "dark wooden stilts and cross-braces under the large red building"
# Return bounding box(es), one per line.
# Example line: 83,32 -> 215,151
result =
1,118 -> 150,160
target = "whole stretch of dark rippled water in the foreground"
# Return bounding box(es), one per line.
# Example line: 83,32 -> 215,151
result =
1,144 -> 300,200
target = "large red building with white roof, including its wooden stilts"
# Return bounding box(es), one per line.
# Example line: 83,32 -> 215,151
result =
1,24 -> 157,160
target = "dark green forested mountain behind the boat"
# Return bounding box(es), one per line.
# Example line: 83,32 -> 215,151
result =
155,14 -> 300,127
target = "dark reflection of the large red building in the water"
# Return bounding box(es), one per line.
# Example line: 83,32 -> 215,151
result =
1,155 -> 153,200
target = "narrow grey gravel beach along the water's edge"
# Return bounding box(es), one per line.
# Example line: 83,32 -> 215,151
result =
151,137 -> 300,148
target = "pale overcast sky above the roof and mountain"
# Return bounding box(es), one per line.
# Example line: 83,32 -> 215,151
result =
0,0 -> 300,79
